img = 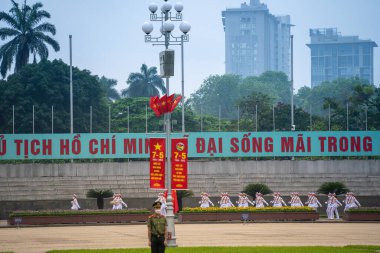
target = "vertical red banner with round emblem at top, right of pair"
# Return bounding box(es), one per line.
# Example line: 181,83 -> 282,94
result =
171,138 -> 188,190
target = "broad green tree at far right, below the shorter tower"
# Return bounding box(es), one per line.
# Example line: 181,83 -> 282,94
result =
295,77 -> 379,130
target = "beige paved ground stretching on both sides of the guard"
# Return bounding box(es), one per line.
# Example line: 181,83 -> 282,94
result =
0,222 -> 380,253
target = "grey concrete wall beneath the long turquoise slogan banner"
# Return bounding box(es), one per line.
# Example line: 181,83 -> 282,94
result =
0,160 -> 380,216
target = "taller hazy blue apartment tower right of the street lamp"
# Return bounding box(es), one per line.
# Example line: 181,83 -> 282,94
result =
222,0 -> 291,77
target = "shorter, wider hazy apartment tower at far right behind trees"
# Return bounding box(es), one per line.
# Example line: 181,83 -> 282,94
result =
307,28 -> 377,88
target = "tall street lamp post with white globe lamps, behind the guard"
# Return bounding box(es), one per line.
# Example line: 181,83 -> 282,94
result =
142,0 -> 191,247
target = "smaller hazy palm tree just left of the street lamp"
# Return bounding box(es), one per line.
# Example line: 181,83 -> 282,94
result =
121,64 -> 166,97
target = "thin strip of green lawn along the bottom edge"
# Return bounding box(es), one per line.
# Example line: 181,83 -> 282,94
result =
48,245 -> 380,253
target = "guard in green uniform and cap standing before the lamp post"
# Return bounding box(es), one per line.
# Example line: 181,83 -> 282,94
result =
148,201 -> 168,253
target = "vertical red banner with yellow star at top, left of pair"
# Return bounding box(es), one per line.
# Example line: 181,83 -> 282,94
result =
149,138 -> 166,189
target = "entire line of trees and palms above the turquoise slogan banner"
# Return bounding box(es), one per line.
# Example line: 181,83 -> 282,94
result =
0,0 -> 380,133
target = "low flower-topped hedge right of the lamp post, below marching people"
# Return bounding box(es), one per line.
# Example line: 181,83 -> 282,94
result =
181,207 -> 315,213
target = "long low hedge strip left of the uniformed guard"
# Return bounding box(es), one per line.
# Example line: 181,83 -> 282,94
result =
9,209 -> 150,218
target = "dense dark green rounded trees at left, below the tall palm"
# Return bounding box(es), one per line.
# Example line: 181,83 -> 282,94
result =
0,60 -> 108,133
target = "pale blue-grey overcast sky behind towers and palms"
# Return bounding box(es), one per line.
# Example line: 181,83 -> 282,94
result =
0,0 -> 380,96
